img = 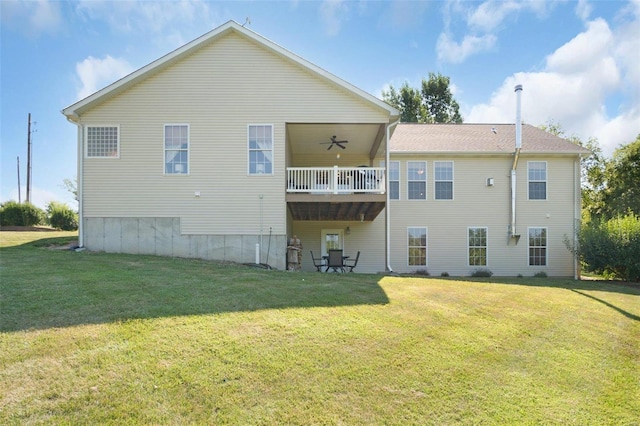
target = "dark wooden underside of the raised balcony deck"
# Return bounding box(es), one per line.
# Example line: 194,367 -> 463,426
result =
287,194 -> 386,222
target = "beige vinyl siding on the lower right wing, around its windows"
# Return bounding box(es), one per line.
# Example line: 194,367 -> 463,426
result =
390,154 -> 576,276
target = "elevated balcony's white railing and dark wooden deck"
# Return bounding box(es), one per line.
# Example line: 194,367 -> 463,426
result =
286,166 -> 387,222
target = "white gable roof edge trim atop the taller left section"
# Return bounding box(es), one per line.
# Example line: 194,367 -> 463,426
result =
62,21 -> 400,122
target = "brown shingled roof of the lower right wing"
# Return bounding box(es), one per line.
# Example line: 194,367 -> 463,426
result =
390,123 -> 591,155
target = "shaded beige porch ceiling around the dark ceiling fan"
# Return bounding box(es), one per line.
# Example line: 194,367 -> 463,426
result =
287,123 -> 384,158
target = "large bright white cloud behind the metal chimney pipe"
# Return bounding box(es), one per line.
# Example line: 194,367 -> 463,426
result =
464,15 -> 640,155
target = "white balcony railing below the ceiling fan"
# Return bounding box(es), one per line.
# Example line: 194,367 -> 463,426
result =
287,166 -> 385,194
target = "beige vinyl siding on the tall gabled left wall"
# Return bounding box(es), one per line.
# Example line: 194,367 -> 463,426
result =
80,33 -> 388,234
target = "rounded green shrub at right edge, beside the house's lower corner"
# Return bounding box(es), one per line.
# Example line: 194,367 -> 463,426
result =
577,213 -> 640,281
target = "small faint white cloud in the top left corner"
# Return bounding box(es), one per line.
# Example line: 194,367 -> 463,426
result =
0,0 -> 62,37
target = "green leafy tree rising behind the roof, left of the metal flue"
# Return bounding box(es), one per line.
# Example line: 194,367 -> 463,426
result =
382,72 -> 462,123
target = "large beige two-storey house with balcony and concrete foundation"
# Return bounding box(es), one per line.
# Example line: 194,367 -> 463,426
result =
62,22 -> 587,276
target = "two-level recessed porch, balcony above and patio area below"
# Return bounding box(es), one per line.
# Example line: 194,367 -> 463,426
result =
283,122 -> 393,273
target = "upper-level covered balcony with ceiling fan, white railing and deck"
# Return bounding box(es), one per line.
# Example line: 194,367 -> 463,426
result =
285,123 -> 389,222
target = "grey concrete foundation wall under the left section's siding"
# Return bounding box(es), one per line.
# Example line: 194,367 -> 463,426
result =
83,217 -> 287,269
